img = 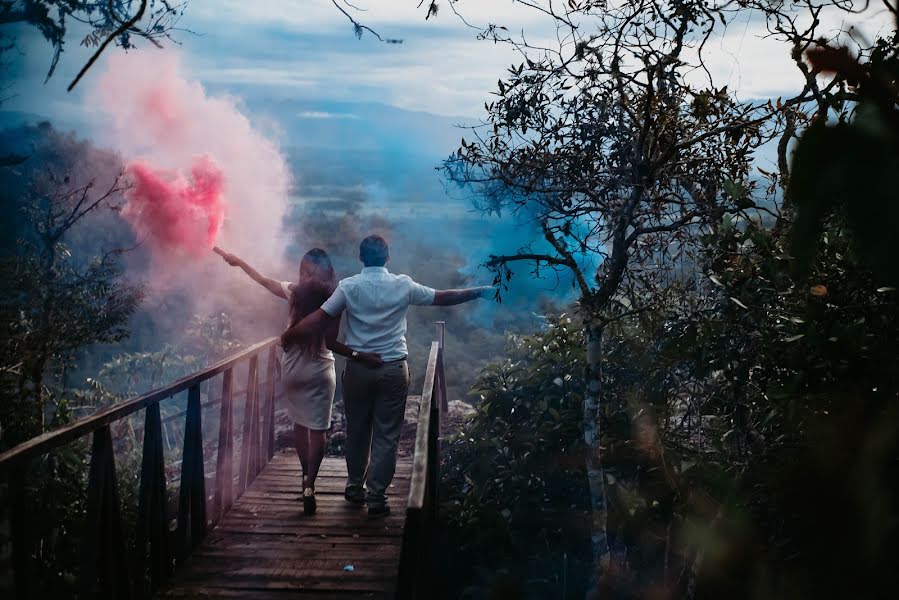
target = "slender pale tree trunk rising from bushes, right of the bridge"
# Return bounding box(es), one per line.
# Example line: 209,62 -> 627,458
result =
584,321 -> 610,598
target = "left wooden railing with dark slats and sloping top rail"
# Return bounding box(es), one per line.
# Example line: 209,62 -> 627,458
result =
0,338 -> 280,600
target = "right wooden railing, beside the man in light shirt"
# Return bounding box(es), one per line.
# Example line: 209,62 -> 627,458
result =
396,321 -> 447,600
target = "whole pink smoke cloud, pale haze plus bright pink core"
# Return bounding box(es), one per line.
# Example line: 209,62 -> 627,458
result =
86,48 -> 293,341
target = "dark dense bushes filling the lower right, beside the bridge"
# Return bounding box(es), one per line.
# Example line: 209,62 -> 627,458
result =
442,165 -> 899,598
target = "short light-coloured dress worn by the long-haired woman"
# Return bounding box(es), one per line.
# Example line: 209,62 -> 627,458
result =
281,281 -> 337,429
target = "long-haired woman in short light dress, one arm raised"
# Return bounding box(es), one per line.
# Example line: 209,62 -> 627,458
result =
222,248 -> 381,515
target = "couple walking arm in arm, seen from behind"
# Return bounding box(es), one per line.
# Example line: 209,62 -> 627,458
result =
223,235 -> 493,518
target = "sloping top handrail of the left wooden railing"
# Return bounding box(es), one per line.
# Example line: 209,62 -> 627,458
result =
0,337 -> 278,471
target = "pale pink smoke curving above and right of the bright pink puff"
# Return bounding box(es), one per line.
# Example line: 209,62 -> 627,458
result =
90,49 -> 290,263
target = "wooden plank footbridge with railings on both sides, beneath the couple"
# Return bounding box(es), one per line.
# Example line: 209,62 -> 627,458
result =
0,322 -> 446,600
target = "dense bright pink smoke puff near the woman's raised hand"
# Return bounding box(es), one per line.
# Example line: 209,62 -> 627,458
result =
122,156 -> 225,257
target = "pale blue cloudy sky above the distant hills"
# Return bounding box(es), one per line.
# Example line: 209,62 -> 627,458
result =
3,0 -> 885,126
